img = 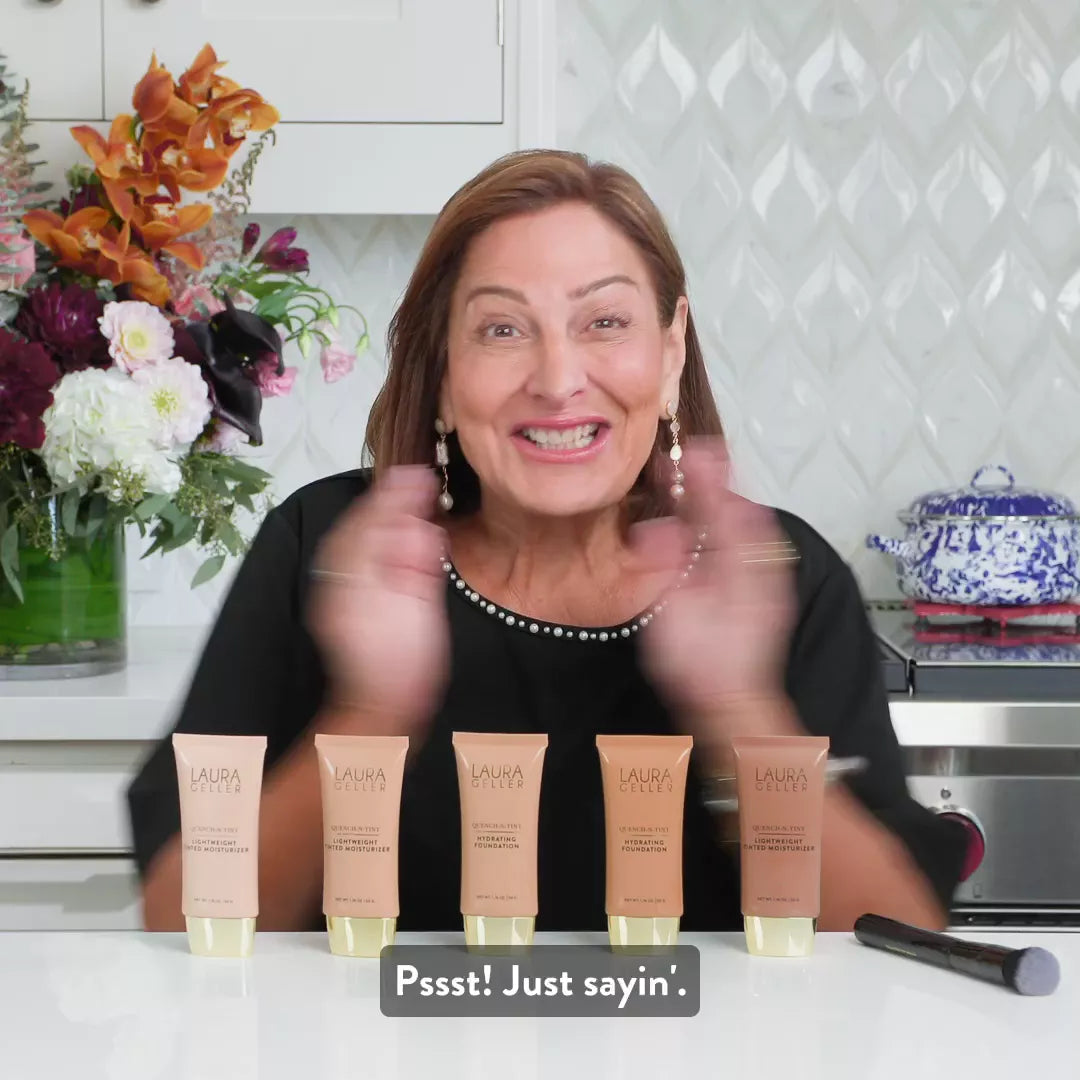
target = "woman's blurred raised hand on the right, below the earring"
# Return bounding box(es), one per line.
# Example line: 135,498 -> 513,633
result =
633,441 -> 795,740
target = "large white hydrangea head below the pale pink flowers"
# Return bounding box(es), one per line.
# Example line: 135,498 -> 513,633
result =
41,367 -> 181,499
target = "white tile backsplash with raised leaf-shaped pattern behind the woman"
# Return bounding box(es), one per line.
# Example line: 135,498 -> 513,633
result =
131,0 -> 1080,625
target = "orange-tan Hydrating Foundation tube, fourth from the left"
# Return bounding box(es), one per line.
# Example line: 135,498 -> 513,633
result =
596,735 -> 693,949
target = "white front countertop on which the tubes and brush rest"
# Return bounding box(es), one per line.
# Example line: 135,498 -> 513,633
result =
0,932 -> 1080,1080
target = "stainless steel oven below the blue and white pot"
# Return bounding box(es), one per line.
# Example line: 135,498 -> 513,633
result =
872,605 -> 1080,928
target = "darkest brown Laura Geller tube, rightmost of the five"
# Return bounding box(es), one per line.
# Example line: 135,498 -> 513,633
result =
731,735 -> 828,957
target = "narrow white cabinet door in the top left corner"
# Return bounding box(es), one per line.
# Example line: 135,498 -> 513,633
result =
0,0 -> 103,120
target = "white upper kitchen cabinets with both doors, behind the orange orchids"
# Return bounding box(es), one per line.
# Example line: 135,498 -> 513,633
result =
14,0 -> 556,214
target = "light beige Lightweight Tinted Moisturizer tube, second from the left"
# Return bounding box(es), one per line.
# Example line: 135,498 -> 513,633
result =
315,734 -> 408,957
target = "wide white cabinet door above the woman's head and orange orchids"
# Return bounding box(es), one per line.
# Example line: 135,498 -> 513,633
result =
105,0 -> 502,124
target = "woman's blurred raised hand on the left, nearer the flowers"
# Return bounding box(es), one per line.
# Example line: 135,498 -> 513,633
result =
310,467 -> 449,734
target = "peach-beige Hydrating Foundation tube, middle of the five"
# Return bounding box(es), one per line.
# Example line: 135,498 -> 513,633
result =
453,731 -> 548,948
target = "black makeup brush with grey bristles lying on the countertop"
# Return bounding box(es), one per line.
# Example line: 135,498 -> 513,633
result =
855,915 -> 1061,996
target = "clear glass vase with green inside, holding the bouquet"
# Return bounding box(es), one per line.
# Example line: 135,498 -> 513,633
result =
0,498 -> 127,679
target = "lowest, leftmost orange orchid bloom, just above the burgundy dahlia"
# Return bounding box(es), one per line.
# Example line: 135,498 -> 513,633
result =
23,206 -> 170,307
